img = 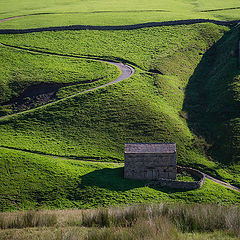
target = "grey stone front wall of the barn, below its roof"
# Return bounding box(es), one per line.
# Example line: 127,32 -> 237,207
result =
124,153 -> 177,180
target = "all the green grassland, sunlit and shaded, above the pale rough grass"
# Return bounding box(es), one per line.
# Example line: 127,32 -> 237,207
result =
0,0 -> 240,216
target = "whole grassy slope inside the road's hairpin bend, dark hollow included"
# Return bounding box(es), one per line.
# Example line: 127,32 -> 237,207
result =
0,45 -> 119,115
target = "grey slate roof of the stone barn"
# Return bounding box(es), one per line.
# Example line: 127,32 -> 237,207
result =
125,143 -> 176,153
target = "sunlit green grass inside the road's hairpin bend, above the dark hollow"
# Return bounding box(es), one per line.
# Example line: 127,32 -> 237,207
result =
0,45 -> 120,103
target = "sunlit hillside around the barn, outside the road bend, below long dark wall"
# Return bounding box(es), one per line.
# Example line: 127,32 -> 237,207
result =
0,24 -> 240,210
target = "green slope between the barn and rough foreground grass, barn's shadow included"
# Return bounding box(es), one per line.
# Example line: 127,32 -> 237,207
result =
0,148 -> 240,211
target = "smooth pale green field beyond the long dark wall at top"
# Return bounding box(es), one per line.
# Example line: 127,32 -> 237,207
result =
0,0 -> 240,29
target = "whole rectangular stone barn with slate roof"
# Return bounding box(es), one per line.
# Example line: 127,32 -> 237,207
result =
124,143 -> 177,180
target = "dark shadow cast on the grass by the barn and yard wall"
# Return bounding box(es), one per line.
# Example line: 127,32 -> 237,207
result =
81,167 -> 191,193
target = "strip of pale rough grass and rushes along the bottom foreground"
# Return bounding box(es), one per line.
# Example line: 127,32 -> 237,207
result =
0,204 -> 240,240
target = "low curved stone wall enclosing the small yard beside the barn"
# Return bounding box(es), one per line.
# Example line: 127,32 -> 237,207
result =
146,166 -> 205,190
